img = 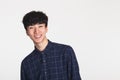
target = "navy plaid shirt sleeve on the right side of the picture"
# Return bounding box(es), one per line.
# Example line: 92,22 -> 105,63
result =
66,47 -> 81,80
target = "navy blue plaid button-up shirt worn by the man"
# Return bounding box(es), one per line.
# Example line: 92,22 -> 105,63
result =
21,41 -> 81,80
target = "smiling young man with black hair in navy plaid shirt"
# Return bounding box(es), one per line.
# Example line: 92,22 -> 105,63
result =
21,11 -> 81,80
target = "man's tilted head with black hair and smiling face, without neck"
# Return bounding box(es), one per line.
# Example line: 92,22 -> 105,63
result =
23,11 -> 48,44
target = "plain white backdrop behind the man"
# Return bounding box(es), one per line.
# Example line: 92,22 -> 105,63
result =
0,0 -> 120,80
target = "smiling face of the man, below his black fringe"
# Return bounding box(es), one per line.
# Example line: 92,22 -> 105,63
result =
26,23 -> 48,44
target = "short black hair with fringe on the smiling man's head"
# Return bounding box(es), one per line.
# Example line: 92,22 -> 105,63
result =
22,11 -> 48,30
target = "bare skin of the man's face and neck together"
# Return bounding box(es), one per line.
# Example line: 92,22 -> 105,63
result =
26,23 -> 48,51
